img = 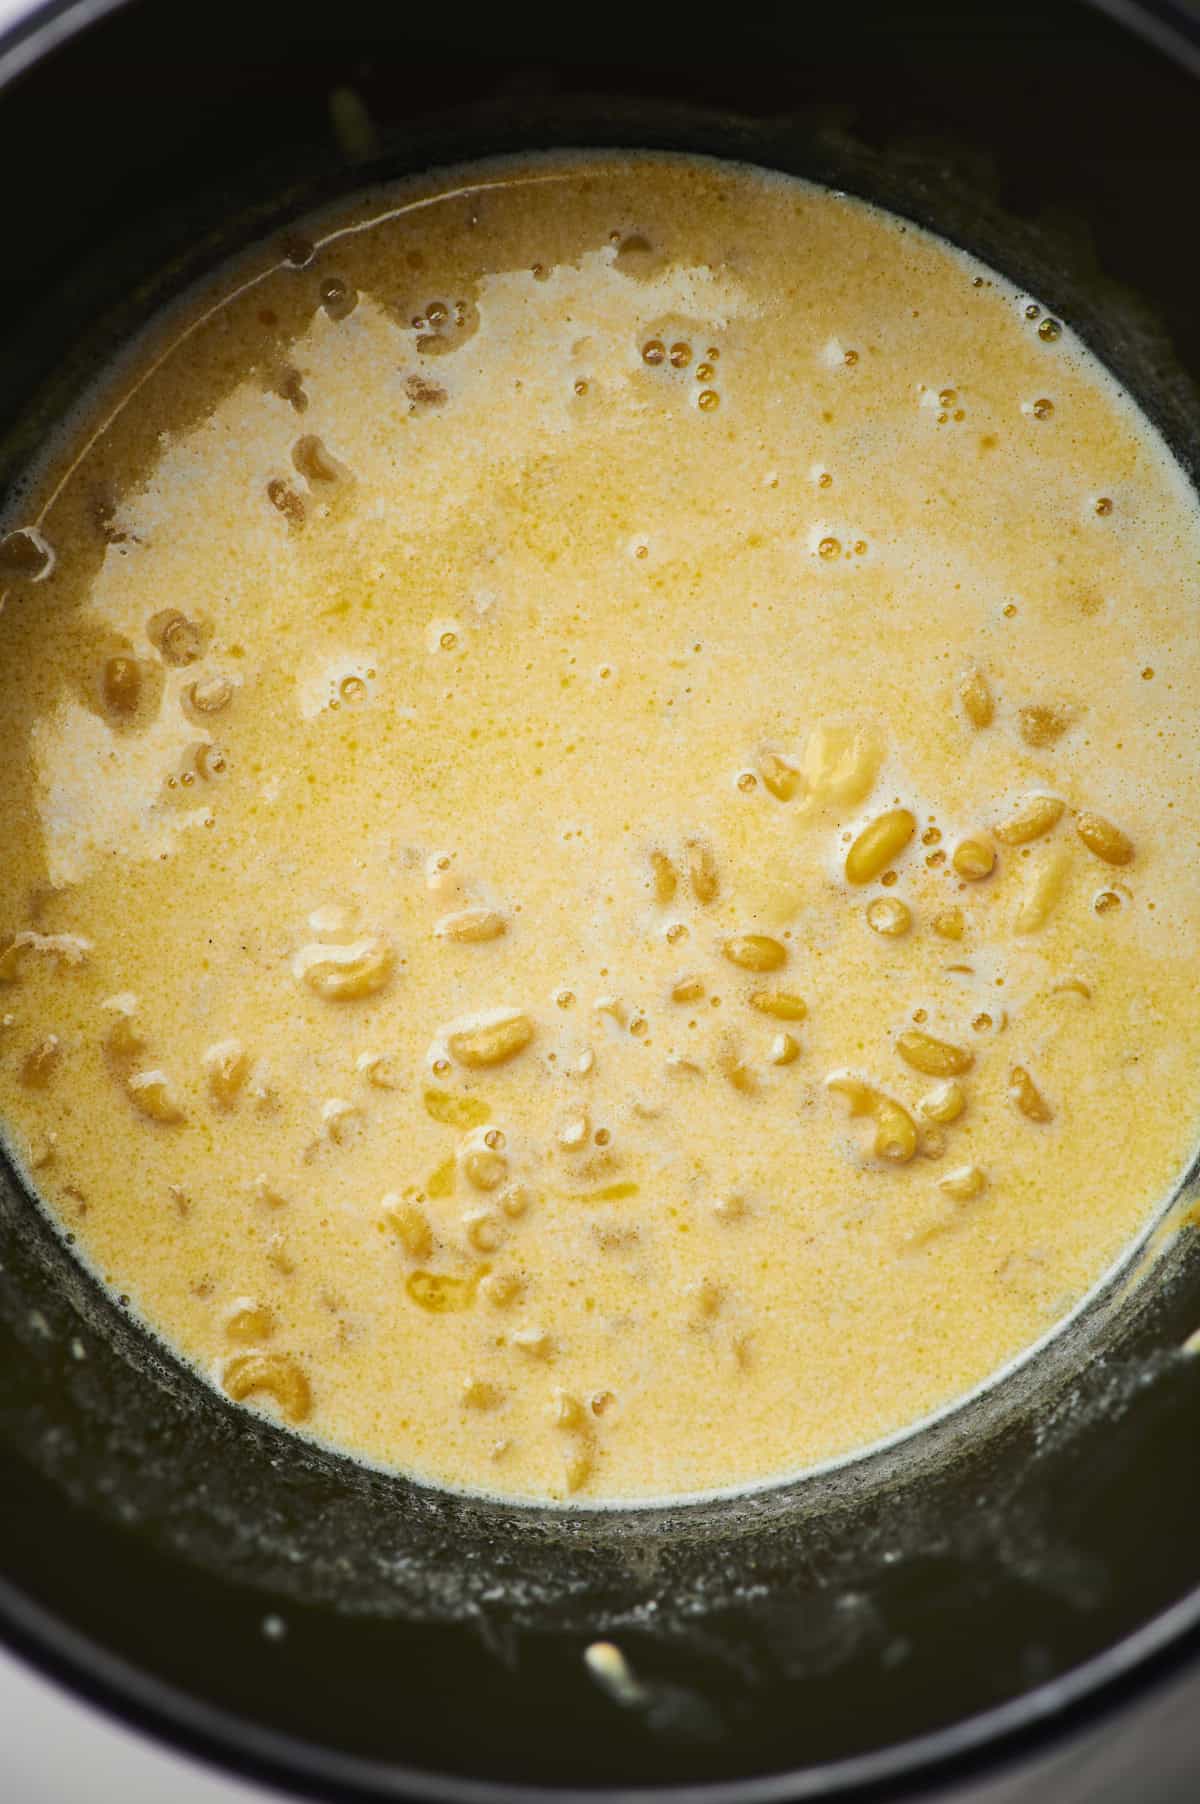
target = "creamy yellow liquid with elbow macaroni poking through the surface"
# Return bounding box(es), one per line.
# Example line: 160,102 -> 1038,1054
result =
0,155 -> 1200,1501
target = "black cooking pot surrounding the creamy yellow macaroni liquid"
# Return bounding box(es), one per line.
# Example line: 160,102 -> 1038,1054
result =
0,0 -> 1200,1800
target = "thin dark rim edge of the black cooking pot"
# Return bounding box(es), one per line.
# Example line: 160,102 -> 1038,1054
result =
0,0 -> 1200,1804
